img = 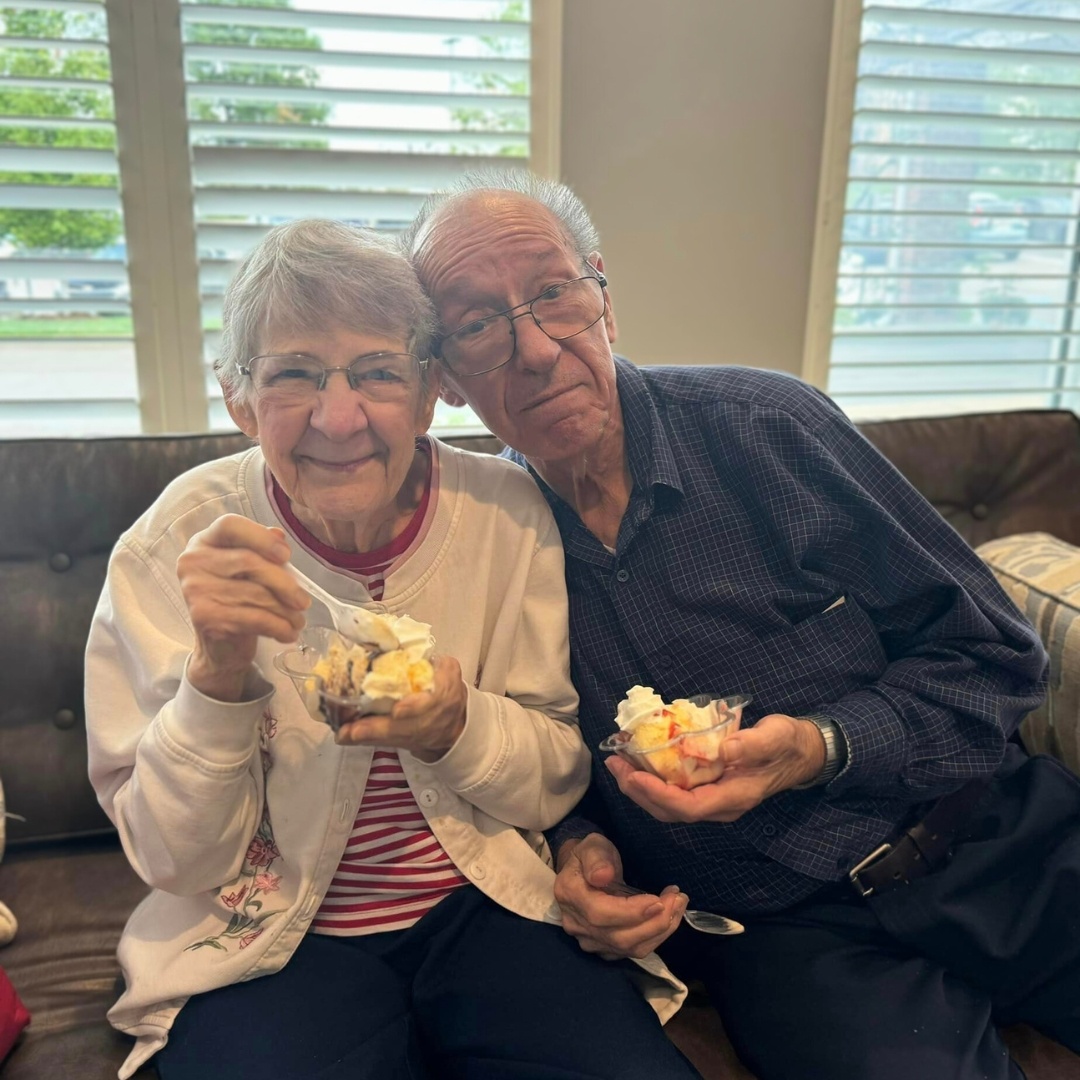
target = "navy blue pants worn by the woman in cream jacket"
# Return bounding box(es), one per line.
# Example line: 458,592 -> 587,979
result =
156,886 -> 700,1080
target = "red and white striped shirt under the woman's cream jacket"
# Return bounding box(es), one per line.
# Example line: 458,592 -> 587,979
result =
271,440 -> 469,936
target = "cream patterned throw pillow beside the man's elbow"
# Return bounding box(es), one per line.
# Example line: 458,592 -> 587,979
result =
975,532 -> 1080,773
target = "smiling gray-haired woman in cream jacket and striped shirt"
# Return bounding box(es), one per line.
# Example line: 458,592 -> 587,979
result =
86,221 -> 697,1080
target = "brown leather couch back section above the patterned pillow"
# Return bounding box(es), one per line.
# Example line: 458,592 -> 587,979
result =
860,409 -> 1080,546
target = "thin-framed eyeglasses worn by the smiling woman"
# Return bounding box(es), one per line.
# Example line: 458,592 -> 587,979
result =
237,352 -> 428,405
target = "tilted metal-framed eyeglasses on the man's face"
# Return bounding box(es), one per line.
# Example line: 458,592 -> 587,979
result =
434,273 -> 607,377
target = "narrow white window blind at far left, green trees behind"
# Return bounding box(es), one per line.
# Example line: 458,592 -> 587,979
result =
0,0 -> 139,436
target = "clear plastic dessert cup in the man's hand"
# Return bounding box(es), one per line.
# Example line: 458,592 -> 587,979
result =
599,693 -> 751,791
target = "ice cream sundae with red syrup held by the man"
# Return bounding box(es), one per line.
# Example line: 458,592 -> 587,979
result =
600,686 -> 750,788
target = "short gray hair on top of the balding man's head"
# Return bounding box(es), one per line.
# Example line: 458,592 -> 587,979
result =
399,168 -> 600,265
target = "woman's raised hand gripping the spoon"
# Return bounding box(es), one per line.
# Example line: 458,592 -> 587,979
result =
176,514 -> 311,701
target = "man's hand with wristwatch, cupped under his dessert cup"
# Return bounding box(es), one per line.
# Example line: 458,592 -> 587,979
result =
605,713 -> 825,822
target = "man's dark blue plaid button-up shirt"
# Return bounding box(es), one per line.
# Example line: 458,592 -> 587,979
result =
509,359 -> 1045,914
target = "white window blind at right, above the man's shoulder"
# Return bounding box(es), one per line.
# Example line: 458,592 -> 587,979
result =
827,0 -> 1080,419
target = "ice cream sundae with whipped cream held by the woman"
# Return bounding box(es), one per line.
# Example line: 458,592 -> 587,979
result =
274,611 -> 435,730
